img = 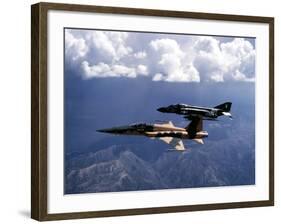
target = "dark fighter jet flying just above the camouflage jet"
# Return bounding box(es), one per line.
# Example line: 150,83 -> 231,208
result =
157,102 -> 232,120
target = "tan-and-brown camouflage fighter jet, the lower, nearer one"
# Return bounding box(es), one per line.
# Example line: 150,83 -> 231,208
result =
97,117 -> 208,152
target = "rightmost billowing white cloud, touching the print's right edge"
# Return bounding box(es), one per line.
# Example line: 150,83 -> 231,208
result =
191,37 -> 255,82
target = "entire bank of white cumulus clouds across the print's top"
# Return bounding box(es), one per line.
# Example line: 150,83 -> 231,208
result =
65,30 -> 255,82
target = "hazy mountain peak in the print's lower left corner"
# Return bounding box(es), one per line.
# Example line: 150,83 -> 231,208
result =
66,148 -> 164,193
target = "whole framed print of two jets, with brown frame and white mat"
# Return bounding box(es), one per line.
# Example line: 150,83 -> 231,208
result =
31,3 -> 274,221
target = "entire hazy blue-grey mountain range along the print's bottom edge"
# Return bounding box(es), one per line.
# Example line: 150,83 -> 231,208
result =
66,130 -> 255,193
